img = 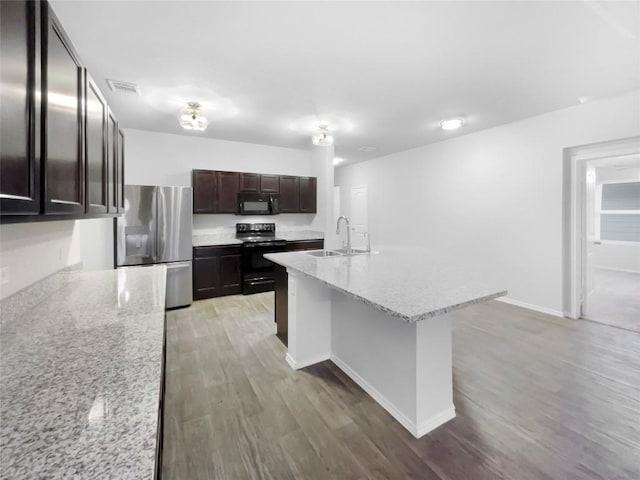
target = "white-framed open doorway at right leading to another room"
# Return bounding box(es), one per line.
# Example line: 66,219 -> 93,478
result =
565,138 -> 640,332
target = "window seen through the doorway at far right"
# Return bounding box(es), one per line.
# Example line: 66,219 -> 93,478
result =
600,182 -> 640,242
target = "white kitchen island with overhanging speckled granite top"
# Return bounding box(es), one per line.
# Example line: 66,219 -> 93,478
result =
265,248 -> 507,438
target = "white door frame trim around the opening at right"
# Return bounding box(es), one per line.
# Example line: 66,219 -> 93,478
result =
562,137 -> 640,318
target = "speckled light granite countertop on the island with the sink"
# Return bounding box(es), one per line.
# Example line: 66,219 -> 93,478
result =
265,248 -> 507,322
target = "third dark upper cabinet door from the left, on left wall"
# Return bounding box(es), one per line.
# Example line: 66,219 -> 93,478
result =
84,70 -> 108,213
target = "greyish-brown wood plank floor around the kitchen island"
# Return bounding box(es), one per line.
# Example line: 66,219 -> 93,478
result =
162,293 -> 640,480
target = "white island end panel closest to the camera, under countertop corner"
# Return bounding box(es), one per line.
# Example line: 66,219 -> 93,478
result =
416,313 -> 456,438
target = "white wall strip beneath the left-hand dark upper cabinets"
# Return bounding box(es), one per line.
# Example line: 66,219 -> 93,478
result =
0,220 -> 84,298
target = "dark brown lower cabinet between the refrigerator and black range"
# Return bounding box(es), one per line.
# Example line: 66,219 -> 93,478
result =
193,245 -> 242,300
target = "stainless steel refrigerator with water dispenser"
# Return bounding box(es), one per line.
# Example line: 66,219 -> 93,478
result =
116,185 -> 193,308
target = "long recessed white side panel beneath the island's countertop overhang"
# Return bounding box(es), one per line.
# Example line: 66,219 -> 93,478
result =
331,291 -> 418,435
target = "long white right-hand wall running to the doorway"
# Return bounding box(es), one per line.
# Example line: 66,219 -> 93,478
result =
336,96 -> 640,313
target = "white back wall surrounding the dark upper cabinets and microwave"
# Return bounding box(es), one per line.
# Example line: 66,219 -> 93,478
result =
125,129 -> 317,233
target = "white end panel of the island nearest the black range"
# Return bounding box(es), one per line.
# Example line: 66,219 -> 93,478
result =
286,269 -> 331,370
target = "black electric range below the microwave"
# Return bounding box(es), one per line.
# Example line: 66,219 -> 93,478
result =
236,223 -> 287,295
